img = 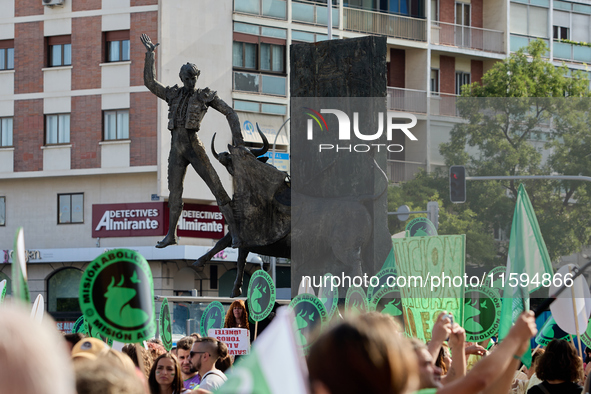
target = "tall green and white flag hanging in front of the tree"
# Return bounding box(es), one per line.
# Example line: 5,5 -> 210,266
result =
499,184 -> 553,368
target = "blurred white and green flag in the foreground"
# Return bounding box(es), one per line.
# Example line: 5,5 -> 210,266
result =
215,308 -> 308,394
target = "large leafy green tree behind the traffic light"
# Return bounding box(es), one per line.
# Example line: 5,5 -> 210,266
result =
440,40 -> 591,261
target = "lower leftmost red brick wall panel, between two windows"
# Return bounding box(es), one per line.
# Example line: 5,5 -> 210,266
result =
13,99 -> 44,172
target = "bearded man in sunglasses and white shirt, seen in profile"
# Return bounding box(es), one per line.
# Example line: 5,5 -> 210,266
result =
191,337 -> 228,391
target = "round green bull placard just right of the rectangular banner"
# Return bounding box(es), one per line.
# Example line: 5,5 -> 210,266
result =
463,286 -> 501,342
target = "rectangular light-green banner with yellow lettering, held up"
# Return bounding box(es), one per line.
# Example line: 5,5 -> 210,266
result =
392,235 -> 466,341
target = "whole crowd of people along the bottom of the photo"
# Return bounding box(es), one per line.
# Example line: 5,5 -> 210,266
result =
0,301 -> 591,394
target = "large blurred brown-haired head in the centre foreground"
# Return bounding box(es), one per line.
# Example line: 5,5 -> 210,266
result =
307,312 -> 418,394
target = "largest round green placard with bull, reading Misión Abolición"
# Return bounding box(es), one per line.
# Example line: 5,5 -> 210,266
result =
80,249 -> 156,343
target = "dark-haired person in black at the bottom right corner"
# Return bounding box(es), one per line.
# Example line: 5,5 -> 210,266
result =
527,339 -> 583,394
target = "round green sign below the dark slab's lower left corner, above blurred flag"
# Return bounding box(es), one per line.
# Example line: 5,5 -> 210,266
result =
289,294 -> 328,354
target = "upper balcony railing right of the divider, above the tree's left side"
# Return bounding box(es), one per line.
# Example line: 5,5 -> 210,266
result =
431,22 -> 505,53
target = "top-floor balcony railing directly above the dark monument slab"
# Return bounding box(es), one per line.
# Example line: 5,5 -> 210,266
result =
343,7 -> 427,41
